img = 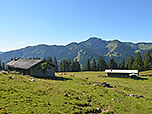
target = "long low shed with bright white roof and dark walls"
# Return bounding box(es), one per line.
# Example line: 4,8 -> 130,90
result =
105,69 -> 138,78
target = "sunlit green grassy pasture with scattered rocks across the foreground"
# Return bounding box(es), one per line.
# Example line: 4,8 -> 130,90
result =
0,71 -> 152,114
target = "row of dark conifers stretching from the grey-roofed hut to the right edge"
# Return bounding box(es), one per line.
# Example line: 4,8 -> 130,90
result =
59,51 -> 152,72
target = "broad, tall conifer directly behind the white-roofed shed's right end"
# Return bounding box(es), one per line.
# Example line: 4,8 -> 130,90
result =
132,52 -> 144,71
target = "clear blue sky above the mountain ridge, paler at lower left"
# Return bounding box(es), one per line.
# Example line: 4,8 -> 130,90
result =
0,0 -> 152,51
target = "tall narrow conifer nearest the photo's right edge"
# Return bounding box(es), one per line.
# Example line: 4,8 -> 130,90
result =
144,51 -> 152,70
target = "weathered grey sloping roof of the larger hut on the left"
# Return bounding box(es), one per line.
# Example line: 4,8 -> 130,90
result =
6,59 -> 43,70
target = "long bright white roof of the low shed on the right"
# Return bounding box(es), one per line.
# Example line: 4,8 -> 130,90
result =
105,69 -> 138,74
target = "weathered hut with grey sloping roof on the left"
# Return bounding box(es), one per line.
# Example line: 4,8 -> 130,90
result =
6,58 -> 55,78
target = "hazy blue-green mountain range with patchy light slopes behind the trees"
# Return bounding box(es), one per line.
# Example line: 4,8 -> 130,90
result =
0,37 -> 152,65
